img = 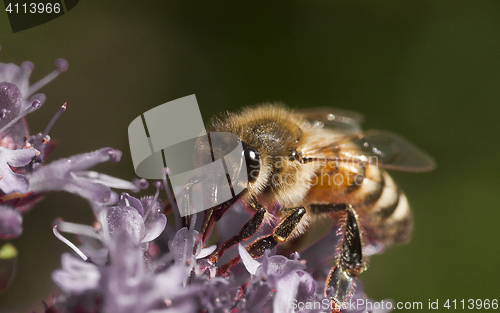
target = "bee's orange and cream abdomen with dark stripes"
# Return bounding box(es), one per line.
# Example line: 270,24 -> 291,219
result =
306,164 -> 412,245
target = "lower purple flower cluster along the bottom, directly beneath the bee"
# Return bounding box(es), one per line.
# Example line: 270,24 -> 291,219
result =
47,178 -> 389,313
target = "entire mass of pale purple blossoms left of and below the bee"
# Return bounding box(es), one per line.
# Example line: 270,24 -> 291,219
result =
0,47 -> 385,313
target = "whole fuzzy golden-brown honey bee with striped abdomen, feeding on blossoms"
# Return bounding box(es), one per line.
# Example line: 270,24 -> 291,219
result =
195,104 -> 435,304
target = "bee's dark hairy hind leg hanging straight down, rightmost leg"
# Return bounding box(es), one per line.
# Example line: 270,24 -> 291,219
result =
325,206 -> 366,307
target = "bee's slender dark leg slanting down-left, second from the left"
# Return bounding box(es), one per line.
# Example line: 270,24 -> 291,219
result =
208,204 -> 267,264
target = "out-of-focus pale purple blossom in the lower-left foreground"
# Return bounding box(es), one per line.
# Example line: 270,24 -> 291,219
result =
52,229 -> 189,313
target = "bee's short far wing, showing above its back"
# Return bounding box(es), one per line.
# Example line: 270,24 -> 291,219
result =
297,108 -> 364,134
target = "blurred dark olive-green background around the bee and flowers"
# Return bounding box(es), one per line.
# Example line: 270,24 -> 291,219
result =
0,0 -> 500,312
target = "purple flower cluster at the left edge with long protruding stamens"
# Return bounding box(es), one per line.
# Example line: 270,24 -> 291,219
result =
0,47 -> 144,291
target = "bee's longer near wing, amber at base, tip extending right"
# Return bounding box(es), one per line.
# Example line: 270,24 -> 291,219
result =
303,130 -> 436,172
